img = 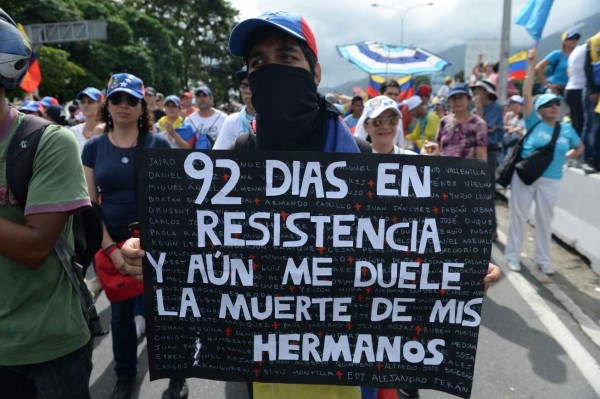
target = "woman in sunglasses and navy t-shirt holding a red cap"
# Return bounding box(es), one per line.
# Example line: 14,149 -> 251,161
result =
82,73 -> 170,399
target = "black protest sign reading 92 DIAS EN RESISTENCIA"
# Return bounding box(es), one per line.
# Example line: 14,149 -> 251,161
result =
139,150 -> 494,397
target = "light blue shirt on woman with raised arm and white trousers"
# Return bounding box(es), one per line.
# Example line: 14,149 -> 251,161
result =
521,111 -> 579,179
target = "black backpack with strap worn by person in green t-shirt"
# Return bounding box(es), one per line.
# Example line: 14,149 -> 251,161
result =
6,115 -> 102,275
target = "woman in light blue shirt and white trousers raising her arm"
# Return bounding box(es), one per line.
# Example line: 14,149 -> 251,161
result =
504,49 -> 583,275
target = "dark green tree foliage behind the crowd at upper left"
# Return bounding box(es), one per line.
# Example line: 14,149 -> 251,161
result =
2,0 -> 242,101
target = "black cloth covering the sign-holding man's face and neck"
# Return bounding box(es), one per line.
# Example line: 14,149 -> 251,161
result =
248,64 -> 325,151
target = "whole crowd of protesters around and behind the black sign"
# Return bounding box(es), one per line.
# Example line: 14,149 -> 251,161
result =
0,3 -> 600,399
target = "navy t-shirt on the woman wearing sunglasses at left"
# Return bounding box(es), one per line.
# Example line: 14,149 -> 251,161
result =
81,133 -> 171,241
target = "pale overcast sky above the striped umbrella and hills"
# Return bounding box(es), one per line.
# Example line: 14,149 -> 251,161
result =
229,0 -> 600,87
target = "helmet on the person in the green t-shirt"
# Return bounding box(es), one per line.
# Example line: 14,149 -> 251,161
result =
0,8 -> 31,90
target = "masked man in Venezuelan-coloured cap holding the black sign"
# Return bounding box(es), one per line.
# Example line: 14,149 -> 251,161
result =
122,12 -> 500,399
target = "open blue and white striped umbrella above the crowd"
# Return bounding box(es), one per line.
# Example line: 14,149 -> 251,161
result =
336,42 -> 451,75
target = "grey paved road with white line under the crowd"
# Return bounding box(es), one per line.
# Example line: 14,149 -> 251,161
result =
92,201 -> 600,399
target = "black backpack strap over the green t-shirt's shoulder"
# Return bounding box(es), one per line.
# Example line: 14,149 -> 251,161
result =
6,115 -> 50,207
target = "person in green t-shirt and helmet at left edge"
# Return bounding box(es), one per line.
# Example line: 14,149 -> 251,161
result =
0,9 -> 92,399
